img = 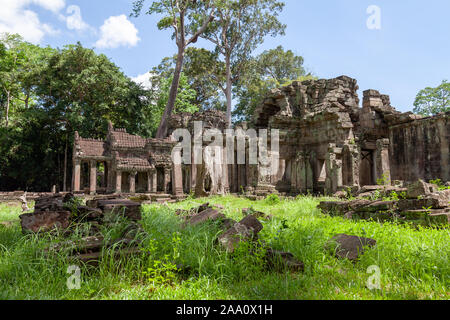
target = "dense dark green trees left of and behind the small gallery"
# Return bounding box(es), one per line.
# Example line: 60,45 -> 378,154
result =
0,35 -> 156,191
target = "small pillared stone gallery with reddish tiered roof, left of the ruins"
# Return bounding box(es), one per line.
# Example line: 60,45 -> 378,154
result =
73,124 -> 175,194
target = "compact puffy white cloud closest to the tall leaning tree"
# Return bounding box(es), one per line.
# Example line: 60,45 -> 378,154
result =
95,14 -> 141,49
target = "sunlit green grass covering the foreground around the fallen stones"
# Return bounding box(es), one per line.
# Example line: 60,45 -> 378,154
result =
0,197 -> 450,300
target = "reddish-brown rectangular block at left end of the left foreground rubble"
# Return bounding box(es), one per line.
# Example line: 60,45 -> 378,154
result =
19,211 -> 71,233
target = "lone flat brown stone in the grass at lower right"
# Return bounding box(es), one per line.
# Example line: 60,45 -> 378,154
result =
325,234 -> 377,261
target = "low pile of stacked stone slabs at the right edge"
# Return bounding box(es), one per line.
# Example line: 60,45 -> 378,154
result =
319,180 -> 450,226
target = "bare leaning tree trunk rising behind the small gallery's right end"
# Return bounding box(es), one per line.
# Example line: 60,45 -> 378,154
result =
156,47 -> 184,139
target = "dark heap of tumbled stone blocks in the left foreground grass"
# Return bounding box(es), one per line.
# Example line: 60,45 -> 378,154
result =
20,194 -> 142,265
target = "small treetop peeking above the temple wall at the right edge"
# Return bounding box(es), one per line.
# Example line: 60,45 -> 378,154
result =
414,80 -> 450,116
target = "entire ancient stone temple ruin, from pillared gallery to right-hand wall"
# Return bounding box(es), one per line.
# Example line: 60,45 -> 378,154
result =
73,76 -> 450,196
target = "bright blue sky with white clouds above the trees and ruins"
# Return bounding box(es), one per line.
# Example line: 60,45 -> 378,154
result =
0,0 -> 450,111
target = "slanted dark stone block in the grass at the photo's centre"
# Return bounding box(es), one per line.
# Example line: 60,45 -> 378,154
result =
218,215 -> 263,252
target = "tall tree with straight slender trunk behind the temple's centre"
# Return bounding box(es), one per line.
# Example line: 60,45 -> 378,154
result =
200,0 -> 286,126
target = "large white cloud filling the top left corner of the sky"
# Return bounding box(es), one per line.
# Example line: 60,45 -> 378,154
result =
0,0 -> 65,43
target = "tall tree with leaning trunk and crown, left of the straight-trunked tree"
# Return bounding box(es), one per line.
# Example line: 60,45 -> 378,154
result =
132,0 -> 217,138
